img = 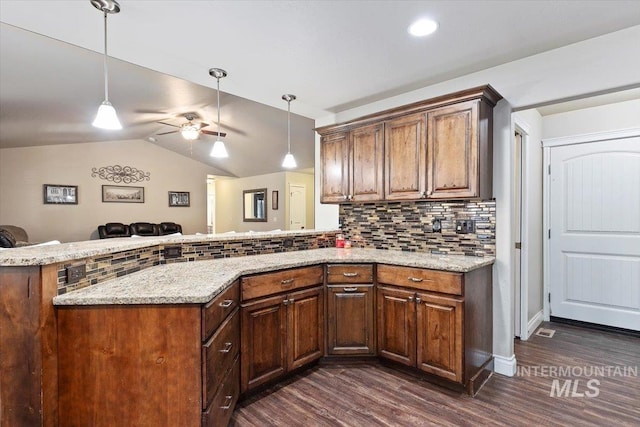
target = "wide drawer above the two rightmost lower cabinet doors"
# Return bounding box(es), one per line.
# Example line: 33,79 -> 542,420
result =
378,265 -> 462,295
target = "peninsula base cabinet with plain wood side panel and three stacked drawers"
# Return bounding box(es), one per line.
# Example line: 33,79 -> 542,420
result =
57,283 -> 240,427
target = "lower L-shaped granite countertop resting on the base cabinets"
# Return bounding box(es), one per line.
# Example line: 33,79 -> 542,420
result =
53,248 -> 495,306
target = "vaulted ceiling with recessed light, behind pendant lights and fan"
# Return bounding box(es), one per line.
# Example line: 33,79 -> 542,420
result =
0,0 -> 640,176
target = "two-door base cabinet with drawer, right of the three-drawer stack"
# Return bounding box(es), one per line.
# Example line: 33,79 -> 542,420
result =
240,266 -> 324,393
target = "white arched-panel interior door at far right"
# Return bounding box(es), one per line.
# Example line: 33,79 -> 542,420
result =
549,137 -> 640,330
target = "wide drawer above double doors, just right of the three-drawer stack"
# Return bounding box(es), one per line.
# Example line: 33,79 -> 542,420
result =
242,265 -> 323,301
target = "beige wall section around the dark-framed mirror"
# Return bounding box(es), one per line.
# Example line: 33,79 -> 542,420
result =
215,172 -> 314,233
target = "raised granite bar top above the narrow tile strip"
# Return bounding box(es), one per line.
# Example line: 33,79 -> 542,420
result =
0,230 -> 339,266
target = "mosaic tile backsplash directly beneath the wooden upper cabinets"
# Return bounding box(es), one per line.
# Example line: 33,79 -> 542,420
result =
340,200 -> 496,256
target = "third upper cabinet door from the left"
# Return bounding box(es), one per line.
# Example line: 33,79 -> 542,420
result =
384,113 -> 427,200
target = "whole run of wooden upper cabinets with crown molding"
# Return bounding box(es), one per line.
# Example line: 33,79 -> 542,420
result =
316,85 -> 502,203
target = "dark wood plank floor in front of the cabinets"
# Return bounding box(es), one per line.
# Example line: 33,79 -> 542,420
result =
231,323 -> 640,427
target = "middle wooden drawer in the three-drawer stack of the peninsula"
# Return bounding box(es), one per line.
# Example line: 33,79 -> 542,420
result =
202,309 -> 240,409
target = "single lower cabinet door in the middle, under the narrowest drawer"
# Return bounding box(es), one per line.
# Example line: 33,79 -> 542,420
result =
327,284 -> 376,356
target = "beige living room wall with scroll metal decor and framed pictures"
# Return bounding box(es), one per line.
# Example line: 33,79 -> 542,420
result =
0,140 -> 218,242
